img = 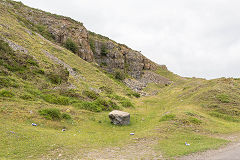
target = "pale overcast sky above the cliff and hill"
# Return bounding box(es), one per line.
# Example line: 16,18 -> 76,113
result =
17,0 -> 240,79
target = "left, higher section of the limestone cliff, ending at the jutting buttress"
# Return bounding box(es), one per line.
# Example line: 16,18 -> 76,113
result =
9,4 -> 94,62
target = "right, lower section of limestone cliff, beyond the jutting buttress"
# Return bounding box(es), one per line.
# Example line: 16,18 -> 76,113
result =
89,34 -> 158,79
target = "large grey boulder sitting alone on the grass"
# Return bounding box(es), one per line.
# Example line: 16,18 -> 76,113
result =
109,110 -> 130,125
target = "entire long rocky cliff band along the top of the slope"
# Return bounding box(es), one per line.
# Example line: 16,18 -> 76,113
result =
2,0 -> 165,79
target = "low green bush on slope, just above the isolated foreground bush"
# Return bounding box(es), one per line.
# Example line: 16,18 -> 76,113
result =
42,94 -> 71,105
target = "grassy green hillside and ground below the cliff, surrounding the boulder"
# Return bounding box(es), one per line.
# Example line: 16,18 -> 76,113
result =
0,1 -> 240,159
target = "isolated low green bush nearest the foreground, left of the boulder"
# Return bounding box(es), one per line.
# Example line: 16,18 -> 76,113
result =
38,108 -> 71,120
